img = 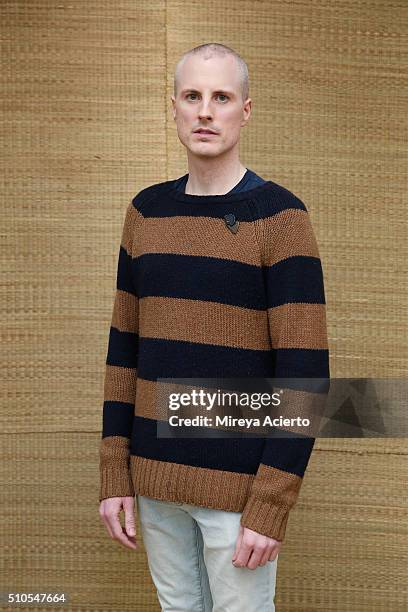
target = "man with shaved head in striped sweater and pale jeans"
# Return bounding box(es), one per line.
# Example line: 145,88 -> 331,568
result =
100,43 -> 329,612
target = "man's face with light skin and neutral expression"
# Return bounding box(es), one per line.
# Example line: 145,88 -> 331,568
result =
171,55 -> 251,157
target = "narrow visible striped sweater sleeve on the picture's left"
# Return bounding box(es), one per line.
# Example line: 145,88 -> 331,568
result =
99,201 -> 138,501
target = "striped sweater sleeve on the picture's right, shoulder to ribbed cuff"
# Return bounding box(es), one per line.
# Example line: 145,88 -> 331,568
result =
241,192 -> 330,541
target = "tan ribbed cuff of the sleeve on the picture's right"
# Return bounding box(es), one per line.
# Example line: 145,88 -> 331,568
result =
241,497 -> 289,541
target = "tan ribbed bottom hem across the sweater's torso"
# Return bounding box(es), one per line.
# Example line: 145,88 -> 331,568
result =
130,455 -> 255,512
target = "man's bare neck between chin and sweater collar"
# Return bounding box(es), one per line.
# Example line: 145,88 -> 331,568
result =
185,158 -> 247,195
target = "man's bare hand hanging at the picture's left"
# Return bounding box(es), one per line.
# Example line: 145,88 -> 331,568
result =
99,497 -> 137,548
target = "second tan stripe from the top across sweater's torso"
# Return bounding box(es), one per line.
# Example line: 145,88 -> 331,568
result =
139,297 -> 271,350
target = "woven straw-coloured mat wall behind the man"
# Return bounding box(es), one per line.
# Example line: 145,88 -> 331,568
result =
0,0 -> 408,612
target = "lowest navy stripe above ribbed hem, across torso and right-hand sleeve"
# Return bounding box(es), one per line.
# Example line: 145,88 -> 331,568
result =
130,416 -> 313,476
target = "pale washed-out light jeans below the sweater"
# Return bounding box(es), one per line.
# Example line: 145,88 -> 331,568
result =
135,494 -> 278,612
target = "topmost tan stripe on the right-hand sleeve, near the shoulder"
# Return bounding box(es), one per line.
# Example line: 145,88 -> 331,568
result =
254,208 -> 319,266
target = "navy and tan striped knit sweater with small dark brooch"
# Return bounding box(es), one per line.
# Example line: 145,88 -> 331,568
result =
99,180 -> 329,540
